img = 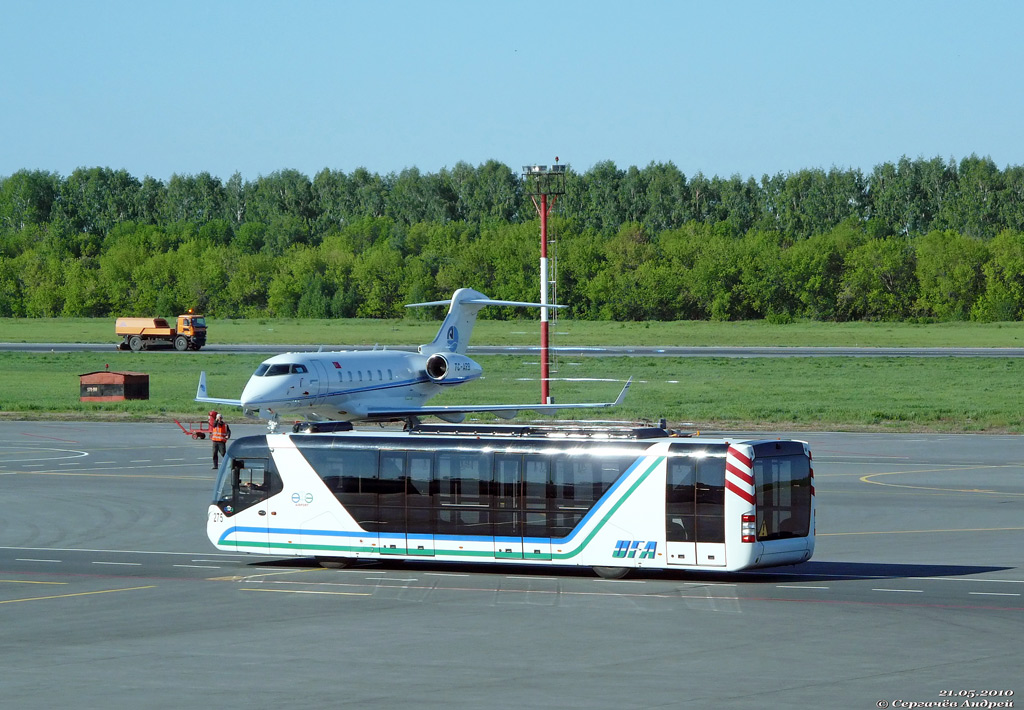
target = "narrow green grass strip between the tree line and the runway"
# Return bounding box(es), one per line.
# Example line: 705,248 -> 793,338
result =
6,318 -> 1024,347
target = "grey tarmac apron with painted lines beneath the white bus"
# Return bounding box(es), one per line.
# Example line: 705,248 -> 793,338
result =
0,422 -> 1024,710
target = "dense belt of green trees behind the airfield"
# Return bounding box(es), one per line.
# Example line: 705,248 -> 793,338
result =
0,156 -> 1024,321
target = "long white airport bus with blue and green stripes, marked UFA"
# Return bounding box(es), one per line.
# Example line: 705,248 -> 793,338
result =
207,425 -> 814,578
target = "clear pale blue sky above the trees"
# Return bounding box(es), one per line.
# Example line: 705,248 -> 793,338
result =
0,0 -> 1024,180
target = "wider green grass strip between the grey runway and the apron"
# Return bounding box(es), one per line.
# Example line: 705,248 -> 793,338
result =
0,348 -> 1024,432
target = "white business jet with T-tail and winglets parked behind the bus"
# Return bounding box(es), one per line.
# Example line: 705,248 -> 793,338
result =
196,289 -> 632,430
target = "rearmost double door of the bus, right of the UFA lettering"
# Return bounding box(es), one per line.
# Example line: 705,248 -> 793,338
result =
665,454 -> 726,567
